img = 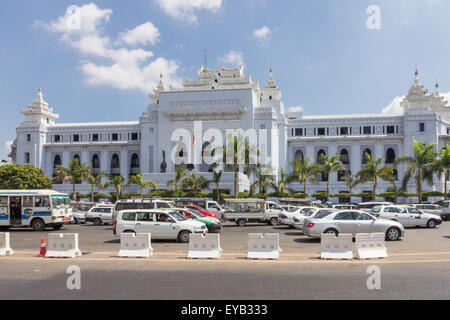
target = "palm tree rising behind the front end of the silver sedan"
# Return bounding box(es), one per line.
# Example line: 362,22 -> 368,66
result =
356,152 -> 394,201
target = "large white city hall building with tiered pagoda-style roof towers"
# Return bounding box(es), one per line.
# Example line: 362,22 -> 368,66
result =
10,67 -> 450,200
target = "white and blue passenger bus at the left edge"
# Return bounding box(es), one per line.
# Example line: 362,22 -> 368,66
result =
0,190 -> 72,231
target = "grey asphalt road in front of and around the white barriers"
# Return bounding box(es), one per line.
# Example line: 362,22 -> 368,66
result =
0,222 -> 450,300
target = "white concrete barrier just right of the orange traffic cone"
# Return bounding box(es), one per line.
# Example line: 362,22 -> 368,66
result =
45,233 -> 81,258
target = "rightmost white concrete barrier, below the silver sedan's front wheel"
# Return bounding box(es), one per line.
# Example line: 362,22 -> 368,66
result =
356,232 -> 388,259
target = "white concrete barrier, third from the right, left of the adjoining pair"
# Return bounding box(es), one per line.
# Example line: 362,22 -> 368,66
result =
247,233 -> 283,259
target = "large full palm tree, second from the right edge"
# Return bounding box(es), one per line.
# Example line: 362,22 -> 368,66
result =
395,140 -> 438,203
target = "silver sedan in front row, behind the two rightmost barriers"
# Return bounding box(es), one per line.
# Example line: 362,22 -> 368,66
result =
303,210 -> 405,241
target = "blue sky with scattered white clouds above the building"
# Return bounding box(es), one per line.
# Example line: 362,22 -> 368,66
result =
0,0 -> 450,159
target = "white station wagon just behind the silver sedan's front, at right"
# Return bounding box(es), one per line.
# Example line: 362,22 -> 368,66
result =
371,205 -> 442,228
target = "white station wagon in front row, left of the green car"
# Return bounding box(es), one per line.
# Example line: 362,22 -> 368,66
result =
113,209 -> 208,242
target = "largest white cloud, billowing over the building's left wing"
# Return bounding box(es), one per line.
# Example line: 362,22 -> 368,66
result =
36,3 -> 181,93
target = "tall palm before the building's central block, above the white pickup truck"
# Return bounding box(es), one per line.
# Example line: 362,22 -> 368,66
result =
219,133 -> 258,198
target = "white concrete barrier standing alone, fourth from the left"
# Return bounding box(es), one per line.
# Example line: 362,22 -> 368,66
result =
188,233 -> 223,259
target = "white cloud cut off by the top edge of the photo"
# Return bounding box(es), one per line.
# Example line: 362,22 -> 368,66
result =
158,0 -> 222,23
